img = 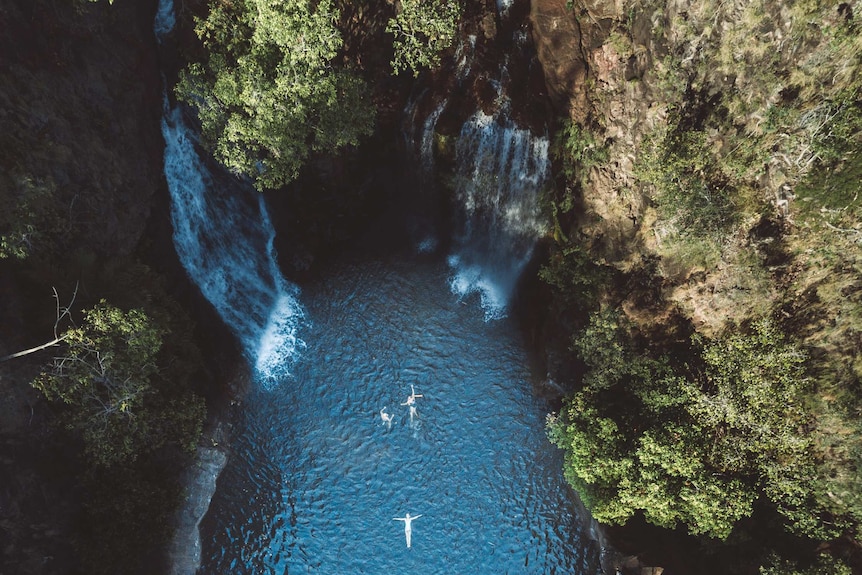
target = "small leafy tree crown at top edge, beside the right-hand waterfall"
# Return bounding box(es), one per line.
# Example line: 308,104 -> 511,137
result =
386,0 -> 461,76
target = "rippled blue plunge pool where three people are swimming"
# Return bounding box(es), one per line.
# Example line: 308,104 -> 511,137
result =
199,258 -> 599,575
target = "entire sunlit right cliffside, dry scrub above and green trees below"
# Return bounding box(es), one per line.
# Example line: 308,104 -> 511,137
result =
541,1 -> 862,573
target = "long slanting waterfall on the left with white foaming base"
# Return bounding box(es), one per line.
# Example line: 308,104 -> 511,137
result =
154,0 -> 304,386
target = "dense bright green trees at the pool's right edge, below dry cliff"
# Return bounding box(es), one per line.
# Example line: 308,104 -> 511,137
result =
549,310 -> 836,539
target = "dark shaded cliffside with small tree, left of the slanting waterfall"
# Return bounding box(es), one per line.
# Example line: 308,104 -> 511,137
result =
0,0 -> 210,573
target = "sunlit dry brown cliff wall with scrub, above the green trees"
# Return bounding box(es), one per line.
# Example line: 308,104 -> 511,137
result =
531,0 -> 862,572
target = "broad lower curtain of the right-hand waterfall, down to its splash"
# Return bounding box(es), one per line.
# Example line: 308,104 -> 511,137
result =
449,106 -> 549,321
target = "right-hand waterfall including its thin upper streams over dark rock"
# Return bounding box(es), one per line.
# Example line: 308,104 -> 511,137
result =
404,13 -> 550,321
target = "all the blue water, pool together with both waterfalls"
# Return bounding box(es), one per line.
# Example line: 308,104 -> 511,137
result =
155,0 -> 600,575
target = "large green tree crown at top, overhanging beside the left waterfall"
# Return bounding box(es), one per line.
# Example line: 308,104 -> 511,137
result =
177,0 -> 374,190
